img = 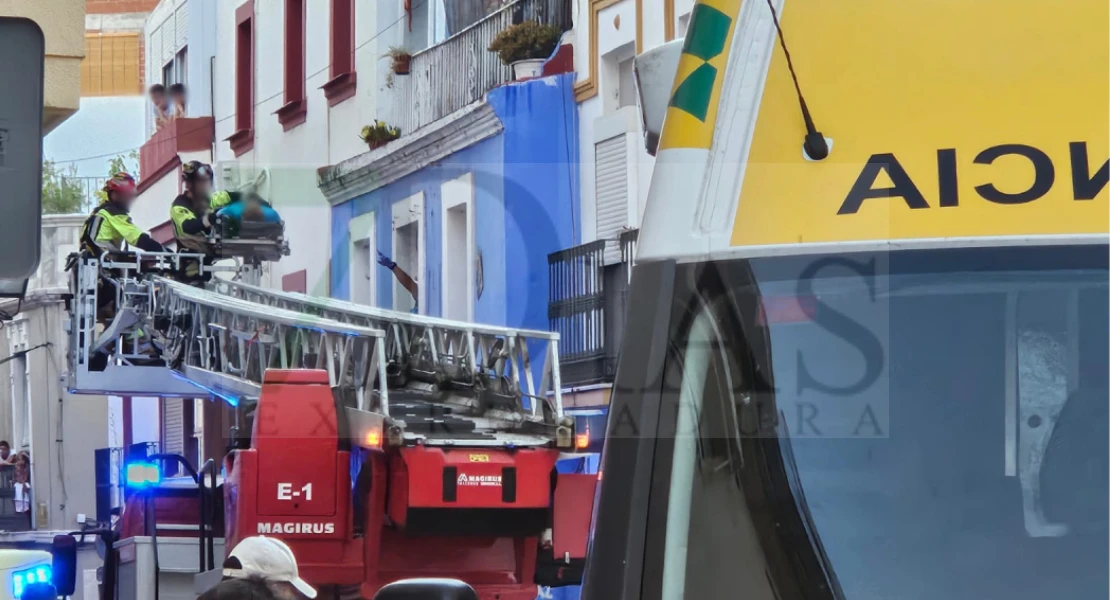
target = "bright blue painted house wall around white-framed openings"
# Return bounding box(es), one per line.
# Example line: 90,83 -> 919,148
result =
330,74 -> 579,330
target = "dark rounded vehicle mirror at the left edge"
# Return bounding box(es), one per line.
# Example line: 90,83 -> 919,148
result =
0,17 -> 46,297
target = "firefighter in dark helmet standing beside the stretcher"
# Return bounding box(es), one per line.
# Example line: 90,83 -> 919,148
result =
170,161 -> 232,283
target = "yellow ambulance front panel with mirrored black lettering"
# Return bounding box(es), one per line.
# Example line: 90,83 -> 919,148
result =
732,0 -> 1110,246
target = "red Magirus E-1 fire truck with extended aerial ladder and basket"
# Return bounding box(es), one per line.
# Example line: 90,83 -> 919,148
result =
60,247 -> 596,600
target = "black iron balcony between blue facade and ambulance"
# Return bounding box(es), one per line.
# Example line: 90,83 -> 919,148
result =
547,230 -> 639,388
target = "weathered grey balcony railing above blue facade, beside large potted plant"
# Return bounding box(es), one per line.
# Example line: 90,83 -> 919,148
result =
393,0 -> 572,134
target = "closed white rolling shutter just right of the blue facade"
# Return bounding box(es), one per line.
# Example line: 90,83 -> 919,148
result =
594,133 -> 628,265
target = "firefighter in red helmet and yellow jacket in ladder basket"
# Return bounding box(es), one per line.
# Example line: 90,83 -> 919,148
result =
81,173 -> 165,256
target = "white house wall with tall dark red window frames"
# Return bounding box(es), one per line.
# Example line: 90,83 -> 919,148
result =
212,0 -> 455,295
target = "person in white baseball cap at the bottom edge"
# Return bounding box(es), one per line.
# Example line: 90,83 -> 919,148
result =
217,536 -> 316,600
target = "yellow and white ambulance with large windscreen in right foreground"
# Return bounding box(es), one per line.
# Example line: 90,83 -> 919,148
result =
583,0 -> 1110,600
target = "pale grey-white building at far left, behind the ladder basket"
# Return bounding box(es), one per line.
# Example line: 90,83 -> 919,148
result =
0,214 -> 112,536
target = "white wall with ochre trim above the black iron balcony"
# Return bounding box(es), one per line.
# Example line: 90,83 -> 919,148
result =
574,0 -> 694,245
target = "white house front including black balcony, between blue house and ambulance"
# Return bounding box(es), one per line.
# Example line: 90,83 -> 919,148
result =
548,0 -> 694,403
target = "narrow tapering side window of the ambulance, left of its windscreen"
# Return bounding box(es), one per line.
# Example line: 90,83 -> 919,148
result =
645,297 -> 774,600
